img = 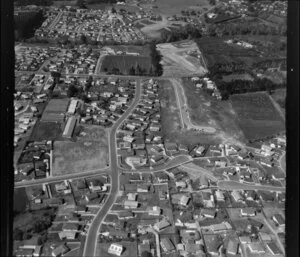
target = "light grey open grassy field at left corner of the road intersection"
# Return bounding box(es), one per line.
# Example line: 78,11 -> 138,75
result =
53,126 -> 109,176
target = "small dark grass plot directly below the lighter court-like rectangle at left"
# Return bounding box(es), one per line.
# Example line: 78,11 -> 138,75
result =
30,122 -> 63,141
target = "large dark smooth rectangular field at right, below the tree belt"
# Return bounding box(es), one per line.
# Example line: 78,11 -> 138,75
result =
230,93 -> 285,140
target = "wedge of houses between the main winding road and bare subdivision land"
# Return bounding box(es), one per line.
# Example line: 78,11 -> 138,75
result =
117,79 -> 167,168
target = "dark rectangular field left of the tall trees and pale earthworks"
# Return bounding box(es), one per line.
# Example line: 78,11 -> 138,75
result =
100,55 -> 152,75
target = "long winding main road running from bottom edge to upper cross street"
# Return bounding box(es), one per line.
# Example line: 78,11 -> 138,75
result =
83,80 -> 141,257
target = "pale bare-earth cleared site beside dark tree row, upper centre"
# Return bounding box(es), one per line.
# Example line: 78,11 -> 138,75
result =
157,40 -> 207,77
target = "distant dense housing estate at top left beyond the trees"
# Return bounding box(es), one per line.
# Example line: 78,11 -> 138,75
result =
35,9 -> 145,43
